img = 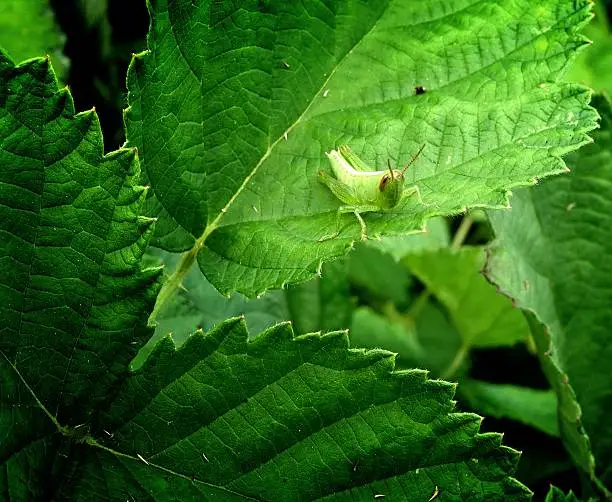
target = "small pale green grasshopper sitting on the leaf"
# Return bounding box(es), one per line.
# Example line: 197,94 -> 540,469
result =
319,145 -> 425,242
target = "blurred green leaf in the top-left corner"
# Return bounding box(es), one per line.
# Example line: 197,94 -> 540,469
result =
0,0 -> 68,79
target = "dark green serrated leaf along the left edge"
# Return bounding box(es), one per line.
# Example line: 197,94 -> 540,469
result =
0,51 -> 159,500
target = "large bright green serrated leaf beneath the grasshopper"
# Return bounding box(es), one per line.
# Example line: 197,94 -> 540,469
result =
126,0 -> 596,296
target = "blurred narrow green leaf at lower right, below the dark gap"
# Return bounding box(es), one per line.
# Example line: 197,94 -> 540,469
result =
459,379 -> 559,436
